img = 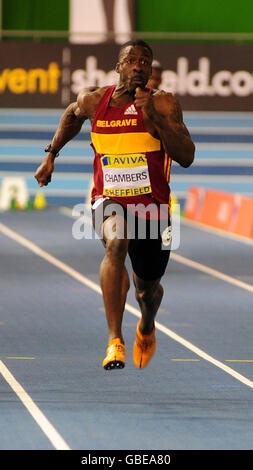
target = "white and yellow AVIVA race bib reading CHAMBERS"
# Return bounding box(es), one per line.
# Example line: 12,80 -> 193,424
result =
101,154 -> 151,197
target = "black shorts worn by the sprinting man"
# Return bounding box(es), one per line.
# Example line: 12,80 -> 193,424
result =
92,198 -> 170,281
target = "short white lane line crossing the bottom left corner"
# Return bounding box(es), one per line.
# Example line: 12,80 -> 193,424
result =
0,360 -> 71,450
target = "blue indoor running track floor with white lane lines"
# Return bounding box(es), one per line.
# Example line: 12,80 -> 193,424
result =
0,207 -> 253,450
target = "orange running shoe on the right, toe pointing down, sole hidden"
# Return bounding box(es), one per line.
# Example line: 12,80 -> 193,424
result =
133,322 -> 156,369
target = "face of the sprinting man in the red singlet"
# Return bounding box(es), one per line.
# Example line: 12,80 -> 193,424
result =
116,46 -> 152,92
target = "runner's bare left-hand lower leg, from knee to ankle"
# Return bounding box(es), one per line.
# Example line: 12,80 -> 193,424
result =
100,215 -> 130,343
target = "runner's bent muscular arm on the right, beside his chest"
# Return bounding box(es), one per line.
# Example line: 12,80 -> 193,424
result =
136,91 -> 195,168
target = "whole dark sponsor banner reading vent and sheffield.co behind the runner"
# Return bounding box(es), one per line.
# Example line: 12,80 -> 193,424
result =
0,41 -> 253,109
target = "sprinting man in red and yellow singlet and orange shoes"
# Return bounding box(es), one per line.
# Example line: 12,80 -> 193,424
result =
35,40 -> 195,370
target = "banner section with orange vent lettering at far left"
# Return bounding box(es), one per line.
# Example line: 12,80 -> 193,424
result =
0,41 -> 63,108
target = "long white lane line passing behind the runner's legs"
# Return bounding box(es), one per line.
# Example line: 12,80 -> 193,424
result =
0,223 -> 253,388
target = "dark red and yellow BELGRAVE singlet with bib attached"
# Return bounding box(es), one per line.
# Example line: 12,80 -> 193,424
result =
91,86 -> 171,214
